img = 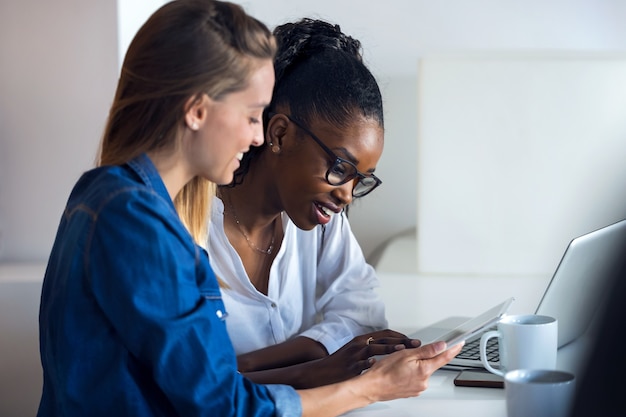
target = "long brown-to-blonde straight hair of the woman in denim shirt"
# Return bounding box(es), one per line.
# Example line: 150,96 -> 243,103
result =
97,0 -> 276,242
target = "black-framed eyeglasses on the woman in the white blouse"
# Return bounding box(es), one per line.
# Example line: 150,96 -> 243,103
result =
270,114 -> 382,198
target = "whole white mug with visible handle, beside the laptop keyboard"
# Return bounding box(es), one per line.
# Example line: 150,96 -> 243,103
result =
480,314 -> 558,376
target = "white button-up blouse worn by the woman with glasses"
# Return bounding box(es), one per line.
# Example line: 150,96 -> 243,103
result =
208,197 -> 387,355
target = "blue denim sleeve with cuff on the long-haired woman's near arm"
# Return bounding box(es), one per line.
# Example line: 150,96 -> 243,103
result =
86,189 -> 300,416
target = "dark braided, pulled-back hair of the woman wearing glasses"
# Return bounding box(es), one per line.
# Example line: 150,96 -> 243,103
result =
231,18 -> 384,186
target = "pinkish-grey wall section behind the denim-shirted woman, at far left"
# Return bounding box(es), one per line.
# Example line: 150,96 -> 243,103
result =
0,0 -> 117,261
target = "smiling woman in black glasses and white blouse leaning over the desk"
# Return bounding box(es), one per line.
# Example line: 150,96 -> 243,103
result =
208,19 -> 412,387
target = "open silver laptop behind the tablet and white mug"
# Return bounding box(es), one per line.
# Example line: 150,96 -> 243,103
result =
410,219 -> 626,372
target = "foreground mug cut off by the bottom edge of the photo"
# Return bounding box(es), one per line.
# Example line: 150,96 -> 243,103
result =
504,369 -> 575,417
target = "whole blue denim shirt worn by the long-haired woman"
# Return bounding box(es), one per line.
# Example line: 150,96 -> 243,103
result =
38,155 -> 302,417
